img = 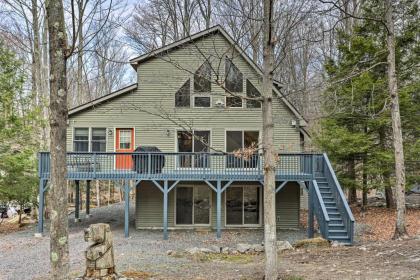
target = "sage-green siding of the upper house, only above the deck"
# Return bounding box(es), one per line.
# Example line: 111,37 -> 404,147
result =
67,35 -> 300,152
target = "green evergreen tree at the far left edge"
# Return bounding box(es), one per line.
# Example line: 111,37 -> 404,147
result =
0,43 -> 37,223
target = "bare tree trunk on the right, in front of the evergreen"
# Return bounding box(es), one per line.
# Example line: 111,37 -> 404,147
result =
385,0 -> 407,238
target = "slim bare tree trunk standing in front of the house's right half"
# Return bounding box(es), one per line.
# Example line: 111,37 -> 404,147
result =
262,0 -> 277,280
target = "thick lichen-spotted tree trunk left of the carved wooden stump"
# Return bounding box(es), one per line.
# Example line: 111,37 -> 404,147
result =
46,0 -> 69,279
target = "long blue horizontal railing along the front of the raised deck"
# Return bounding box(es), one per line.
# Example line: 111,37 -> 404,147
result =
39,152 -> 315,180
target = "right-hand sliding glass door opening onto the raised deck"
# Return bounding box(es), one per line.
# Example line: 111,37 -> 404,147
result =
226,131 -> 259,168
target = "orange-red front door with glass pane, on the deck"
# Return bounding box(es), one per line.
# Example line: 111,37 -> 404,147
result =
115,128 -> 134,169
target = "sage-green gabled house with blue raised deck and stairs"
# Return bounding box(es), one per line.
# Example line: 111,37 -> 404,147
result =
39,26 -> 354,243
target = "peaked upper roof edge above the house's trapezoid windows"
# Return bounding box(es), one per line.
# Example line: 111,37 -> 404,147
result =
130,25 -> 307,126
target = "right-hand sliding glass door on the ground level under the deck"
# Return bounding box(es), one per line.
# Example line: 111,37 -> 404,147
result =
226,186 -> 260,225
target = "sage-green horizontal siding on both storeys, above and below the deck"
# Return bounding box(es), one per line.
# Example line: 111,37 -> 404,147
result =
67,32 -> 301,228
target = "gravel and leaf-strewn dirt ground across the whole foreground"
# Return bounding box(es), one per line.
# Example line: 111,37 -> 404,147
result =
0,204 -> 420,280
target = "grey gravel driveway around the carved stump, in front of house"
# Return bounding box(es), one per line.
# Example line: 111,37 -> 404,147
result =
0,203 -> 305,280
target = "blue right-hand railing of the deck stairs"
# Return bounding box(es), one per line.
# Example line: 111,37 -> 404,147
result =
323,153 -> 354,243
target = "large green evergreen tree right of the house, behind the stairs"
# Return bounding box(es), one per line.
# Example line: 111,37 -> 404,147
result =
316,1 -> 420,207
